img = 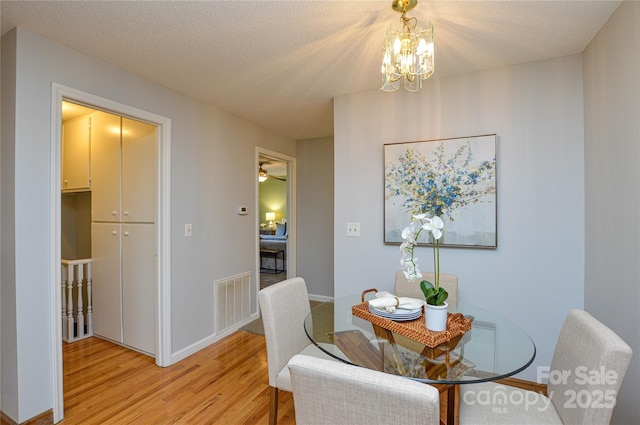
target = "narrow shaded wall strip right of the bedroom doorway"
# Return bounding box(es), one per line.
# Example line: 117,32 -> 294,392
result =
296,137 -> 333,300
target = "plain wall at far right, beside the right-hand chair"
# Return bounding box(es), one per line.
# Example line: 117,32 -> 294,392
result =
584,2 -> 640,424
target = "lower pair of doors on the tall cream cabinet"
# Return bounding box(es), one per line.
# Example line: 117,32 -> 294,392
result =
91,223 -> 156,354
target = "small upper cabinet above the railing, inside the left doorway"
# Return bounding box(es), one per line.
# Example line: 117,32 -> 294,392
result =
61,116 -> 91,192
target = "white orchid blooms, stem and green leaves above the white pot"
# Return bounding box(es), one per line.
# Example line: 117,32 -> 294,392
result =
400,214 -> 449,306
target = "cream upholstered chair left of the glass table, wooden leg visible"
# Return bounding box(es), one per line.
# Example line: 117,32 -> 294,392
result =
258,277 -> 337,425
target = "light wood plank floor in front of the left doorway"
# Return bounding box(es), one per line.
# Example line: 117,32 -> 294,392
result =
60,331 -> 295,425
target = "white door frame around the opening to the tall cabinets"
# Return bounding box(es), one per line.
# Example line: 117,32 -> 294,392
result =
49,83 -> 171,423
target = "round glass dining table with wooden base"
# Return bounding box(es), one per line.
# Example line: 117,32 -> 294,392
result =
304,295 -> 536,424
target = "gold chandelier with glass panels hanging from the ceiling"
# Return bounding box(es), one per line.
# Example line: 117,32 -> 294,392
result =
380,0 -> 434,91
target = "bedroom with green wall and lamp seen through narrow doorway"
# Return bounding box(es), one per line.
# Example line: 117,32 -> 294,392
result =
256,150 -> 294,290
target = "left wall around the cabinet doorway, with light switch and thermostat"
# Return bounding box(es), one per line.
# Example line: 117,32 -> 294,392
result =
2,29 -> 295,423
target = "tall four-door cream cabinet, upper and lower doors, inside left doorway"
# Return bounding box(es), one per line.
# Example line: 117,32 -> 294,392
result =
91,112 -> 158,355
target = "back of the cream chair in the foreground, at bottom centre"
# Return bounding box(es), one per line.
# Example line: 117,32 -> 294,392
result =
289,355 -> 440,425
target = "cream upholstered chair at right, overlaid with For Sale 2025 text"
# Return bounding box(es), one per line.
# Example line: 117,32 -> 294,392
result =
460,310 -> 632,425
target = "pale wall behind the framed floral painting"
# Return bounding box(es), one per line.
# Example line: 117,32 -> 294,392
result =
334,55 -> 584,380
